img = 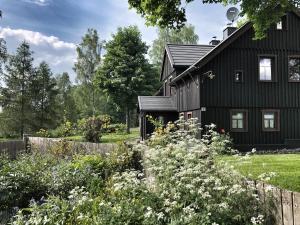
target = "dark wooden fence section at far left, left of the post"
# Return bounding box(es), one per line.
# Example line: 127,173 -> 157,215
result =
0,140 -> 25,158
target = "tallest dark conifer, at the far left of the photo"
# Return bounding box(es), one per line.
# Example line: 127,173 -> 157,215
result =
0,42 -> 35,136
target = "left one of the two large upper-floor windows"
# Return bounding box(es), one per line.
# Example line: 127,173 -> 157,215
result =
259,56 -> 275,81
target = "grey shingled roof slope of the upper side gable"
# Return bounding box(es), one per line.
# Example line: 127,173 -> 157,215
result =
166,44 -> 215,66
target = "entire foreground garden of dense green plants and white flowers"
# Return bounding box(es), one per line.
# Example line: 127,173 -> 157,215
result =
0,119 -> 273,225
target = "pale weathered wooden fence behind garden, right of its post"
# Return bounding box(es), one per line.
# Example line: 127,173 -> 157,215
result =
28,137 -> 117,155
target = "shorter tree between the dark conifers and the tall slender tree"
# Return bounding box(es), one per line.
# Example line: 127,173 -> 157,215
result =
56,72 -> 78,123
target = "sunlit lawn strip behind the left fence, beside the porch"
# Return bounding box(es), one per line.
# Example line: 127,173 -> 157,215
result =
67,127 -> 139,143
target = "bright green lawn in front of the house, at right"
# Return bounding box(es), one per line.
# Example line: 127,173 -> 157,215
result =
219,154 -> 300,192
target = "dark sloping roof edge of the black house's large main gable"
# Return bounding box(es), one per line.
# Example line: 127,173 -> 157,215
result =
171,8 -> 300,84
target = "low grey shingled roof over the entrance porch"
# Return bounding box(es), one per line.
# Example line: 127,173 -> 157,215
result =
138,96 -> 177,112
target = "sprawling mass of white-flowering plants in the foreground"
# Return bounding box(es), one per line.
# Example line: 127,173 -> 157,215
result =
8,119 -> 274,225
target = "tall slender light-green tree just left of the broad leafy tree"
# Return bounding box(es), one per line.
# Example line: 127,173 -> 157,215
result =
74,29 -> 104,115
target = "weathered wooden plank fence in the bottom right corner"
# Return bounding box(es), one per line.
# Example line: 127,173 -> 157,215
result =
257,183 -> 300,225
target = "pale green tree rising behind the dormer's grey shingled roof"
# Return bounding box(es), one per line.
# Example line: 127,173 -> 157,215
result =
150,25 -> 199,70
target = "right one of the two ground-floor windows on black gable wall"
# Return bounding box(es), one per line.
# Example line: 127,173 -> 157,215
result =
262,110 -> 279,131
